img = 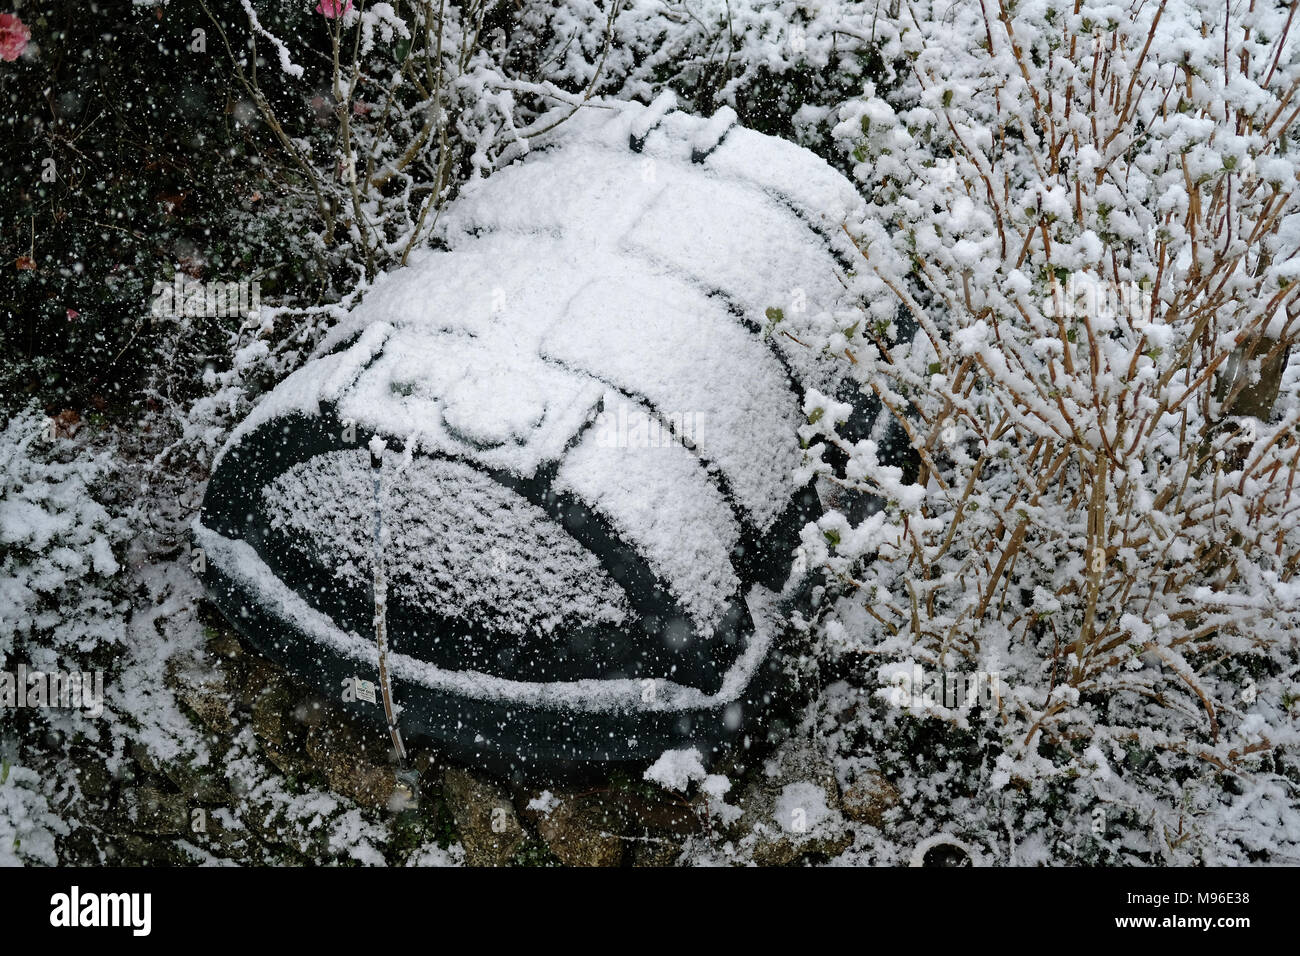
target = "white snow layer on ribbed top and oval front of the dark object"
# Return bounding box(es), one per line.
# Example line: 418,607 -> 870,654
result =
202,96 -> 853,658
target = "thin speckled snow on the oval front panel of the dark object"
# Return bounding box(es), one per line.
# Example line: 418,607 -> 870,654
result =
261,449 -> 628,639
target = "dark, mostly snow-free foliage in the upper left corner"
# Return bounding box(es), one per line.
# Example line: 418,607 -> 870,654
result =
0,0 -> 322,414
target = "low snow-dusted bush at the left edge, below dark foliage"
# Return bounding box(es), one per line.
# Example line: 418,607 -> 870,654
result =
0,406 -> 130,866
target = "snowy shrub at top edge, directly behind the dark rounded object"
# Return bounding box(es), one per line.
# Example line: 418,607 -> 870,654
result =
510,0 -> 896,148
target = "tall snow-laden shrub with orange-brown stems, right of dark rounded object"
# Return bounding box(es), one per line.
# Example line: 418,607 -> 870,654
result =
803,0 -> 1300,849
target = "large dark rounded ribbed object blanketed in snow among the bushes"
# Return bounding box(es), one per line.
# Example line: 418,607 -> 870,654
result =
195,101 -> 858,762
